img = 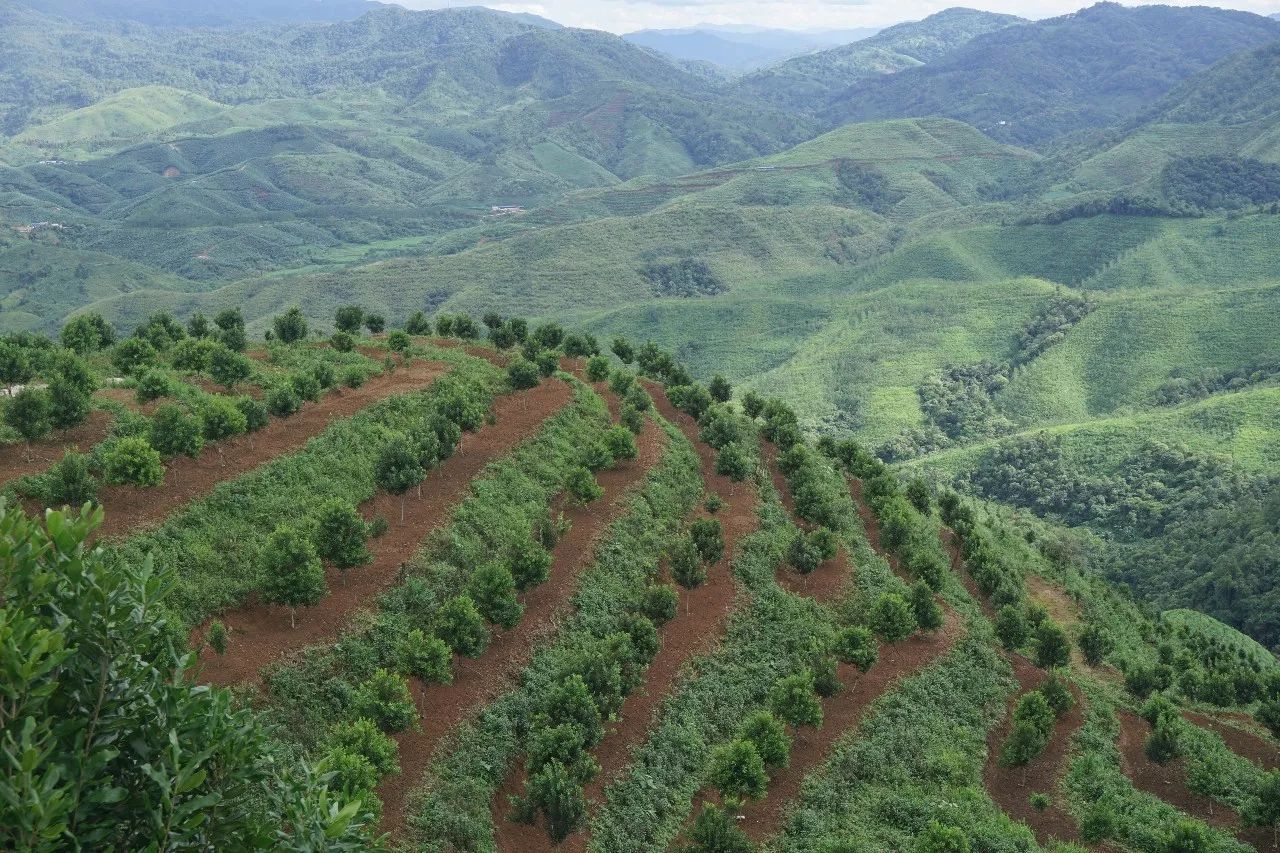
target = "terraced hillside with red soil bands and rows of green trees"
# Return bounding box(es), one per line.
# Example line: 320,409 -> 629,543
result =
4,306 -> 1280,850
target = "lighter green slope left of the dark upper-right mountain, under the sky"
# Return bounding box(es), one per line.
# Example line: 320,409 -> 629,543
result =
733,8 -> 1023,111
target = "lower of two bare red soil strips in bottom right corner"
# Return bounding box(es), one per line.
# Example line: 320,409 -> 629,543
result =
1116,708 -> 1274,850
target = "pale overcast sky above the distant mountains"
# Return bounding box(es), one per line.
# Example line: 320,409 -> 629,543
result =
397,0 -> 1280,33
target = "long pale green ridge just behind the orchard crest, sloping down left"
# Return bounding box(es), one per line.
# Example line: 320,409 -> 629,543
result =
77,119 -> 1029,333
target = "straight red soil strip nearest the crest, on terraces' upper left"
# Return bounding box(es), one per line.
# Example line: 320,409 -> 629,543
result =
97,361 -> 447,538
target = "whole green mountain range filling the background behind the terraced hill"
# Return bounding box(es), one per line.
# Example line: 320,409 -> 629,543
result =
0,0 -> 1280,643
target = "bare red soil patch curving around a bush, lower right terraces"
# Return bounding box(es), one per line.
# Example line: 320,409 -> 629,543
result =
982,654 -> 1084,844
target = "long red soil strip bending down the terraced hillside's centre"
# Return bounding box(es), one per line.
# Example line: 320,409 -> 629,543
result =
514,383 -> 760,852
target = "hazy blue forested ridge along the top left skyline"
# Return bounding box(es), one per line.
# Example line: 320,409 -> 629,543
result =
0,0 -> 747,134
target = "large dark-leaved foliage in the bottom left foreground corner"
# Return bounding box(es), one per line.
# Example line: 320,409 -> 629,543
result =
0,501 -> 380,850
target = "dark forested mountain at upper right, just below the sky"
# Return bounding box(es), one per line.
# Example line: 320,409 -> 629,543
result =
827,3 -> 1280,145
